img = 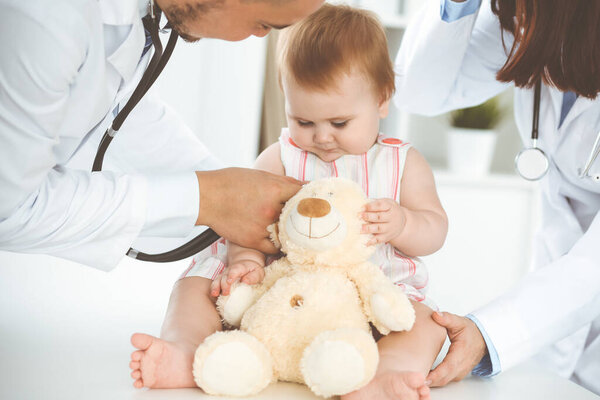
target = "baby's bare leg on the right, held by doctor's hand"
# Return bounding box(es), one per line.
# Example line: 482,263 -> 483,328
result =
342,302 -> 446,400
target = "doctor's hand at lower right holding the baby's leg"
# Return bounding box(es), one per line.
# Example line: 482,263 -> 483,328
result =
427,312 -> 487,387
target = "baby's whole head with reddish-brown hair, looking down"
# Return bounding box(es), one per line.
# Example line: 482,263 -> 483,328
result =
278,4 -> 394,161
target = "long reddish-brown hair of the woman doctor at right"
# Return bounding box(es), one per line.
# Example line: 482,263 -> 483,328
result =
492,0 -> 600,99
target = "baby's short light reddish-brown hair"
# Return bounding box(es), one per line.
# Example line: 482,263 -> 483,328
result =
278,3 -> 395,101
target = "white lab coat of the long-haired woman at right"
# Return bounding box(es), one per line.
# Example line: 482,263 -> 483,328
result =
395,0 -> 600,393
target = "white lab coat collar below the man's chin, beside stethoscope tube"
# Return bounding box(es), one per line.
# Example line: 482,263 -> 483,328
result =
98,0 -> 148,82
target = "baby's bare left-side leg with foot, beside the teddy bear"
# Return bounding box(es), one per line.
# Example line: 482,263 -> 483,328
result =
129,277 -> 221,388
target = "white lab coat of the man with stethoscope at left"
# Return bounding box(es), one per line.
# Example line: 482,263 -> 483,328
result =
0,0 -> 220,270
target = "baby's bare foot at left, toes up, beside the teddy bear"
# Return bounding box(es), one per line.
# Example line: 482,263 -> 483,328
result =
129,333 -> 196,389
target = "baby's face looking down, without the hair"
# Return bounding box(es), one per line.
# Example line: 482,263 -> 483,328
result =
282,73 -> 389,162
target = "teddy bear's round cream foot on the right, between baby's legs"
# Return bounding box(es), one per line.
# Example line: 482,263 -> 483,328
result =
300,328 -> 379,397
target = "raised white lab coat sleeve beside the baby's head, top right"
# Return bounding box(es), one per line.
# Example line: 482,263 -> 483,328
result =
394,0 -> 512,115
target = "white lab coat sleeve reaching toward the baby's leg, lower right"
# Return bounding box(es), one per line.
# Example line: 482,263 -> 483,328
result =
473,214 -> 600,371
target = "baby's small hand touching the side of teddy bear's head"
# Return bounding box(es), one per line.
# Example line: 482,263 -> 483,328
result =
362,199 -> 406,245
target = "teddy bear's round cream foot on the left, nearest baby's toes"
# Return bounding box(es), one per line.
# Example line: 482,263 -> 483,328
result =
193,331 -> 273,396
